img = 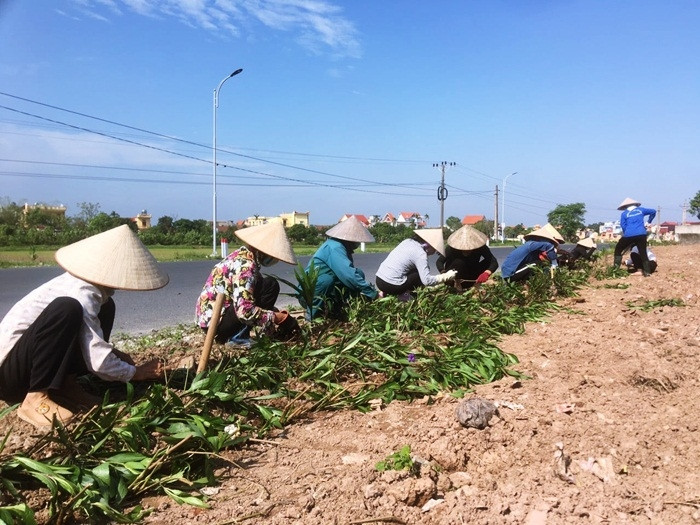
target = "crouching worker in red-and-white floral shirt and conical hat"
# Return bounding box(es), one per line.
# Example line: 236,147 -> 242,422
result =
195,222 -> 299,347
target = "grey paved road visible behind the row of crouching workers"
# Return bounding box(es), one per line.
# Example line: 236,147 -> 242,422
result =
0,247 -> 512,334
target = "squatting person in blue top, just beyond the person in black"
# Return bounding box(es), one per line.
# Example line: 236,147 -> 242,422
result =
501,224 -> 564,282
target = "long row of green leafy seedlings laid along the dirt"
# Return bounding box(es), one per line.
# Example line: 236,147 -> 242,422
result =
0,256 -> 590,524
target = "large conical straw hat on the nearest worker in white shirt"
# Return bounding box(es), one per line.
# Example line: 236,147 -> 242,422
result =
55,224 -> 170,290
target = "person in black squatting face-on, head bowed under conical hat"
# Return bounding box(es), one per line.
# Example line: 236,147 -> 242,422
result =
436,224 -> 498,291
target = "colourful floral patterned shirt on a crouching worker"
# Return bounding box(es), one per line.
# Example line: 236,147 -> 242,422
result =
195,246 -> 275,333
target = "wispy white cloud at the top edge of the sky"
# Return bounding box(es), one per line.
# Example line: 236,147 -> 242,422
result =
67,0 -> 361,58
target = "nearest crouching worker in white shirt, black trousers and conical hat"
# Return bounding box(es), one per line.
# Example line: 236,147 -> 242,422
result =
0,225 -> 168,428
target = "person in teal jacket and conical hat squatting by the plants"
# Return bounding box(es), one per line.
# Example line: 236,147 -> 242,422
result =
306,216 -> 378,319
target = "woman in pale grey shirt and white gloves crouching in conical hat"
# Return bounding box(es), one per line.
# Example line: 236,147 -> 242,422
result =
376,228 -> 457,299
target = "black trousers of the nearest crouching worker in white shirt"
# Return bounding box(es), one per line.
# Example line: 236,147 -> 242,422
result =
0,297 -> 116,403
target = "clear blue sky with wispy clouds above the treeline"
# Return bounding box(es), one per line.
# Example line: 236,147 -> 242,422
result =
0,0 -> 700,226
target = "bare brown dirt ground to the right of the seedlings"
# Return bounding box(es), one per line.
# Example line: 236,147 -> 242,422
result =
1,245 -> 700,525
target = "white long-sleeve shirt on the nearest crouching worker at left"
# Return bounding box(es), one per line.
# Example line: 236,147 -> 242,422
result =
0,273 -> 136,382
